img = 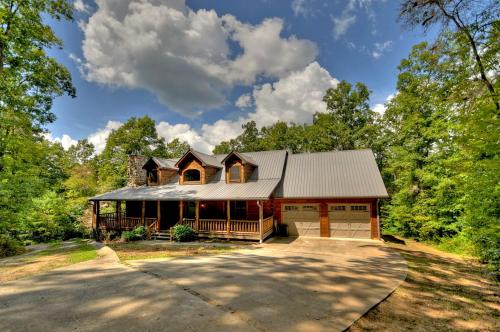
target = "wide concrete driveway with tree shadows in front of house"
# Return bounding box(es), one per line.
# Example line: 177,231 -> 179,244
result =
0,238 -> 406,331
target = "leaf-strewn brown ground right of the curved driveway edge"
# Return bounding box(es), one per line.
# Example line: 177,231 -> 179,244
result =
350,239 -> 500,331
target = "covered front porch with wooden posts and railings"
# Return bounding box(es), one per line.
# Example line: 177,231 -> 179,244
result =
93,200 -> 274,241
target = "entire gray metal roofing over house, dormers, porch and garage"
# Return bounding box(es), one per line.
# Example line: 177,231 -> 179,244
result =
90,150 -> 388,200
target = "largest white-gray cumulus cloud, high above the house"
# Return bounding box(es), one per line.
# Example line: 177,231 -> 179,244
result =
81,0 -> 317,116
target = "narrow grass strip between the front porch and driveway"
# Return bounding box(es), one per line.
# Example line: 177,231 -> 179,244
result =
109,243 -> 240,261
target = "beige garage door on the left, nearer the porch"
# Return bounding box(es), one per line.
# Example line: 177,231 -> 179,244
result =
283,204 -> 320,236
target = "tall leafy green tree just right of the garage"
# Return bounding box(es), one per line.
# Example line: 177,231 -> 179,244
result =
383,43 -> 461,240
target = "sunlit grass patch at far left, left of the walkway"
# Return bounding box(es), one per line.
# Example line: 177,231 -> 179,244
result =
0,240 -> 97,283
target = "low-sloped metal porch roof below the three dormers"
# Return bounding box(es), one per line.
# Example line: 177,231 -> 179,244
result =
90,179 -> 280,201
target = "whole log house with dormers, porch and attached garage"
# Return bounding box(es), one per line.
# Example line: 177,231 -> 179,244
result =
90,149 -> 387,241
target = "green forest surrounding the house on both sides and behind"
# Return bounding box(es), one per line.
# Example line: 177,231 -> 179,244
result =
0,0 -> 500,273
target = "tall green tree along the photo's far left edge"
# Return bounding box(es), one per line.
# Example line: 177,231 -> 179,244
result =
0,0 -> 75,243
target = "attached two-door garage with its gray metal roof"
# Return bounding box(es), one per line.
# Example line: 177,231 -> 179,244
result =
274,150 -> 388,239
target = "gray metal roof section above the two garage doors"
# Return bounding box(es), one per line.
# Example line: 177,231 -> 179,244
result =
275,150 -> 388,198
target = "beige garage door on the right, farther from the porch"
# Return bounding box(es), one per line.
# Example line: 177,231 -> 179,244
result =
328,204 -> 371,239
